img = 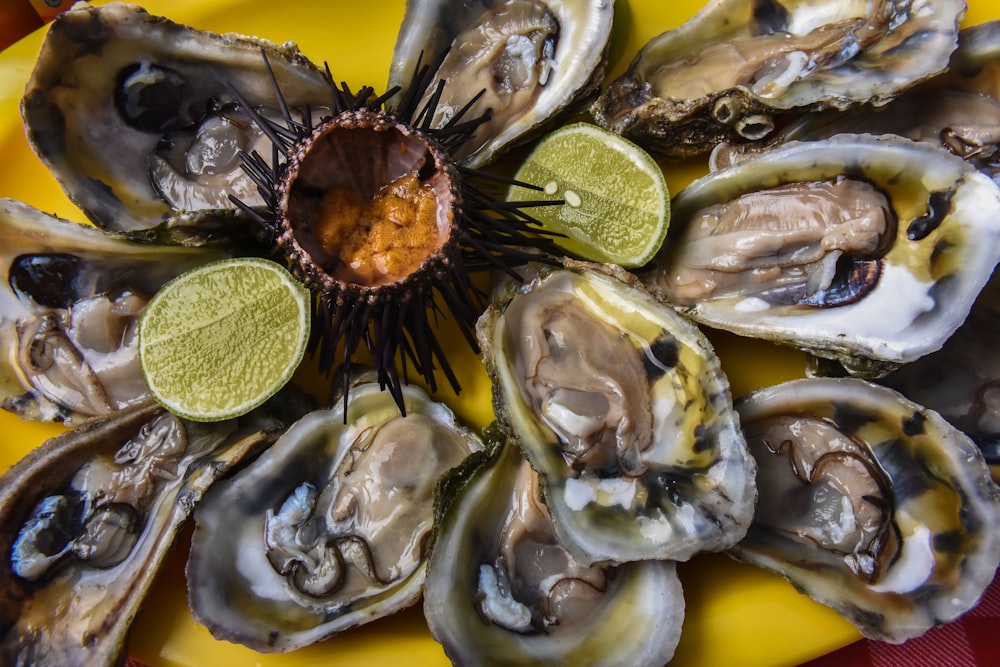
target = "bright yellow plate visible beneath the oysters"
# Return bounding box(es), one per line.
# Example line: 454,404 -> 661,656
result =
0,0 -> 1000,667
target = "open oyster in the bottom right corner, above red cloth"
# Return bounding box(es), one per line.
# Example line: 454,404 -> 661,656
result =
731,378 -> 1000,643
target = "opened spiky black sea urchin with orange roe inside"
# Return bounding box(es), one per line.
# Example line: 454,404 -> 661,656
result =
233,56 -> 559,414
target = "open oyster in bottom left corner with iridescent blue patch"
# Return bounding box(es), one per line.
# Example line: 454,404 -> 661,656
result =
0,402 -> 280,667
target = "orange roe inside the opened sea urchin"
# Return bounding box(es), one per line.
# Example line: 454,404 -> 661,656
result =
314,173 -> 442,285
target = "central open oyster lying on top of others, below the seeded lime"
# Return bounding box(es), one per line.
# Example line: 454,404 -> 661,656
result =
477,262 -> 755,565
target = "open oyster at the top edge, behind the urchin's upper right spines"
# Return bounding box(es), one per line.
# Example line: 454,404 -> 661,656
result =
389,0 -> 614,167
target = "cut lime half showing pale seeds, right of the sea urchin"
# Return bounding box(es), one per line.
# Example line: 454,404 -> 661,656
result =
507,123 -> 670,267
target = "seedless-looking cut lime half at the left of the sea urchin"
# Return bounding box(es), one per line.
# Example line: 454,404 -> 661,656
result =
139,257 -> 311,421
